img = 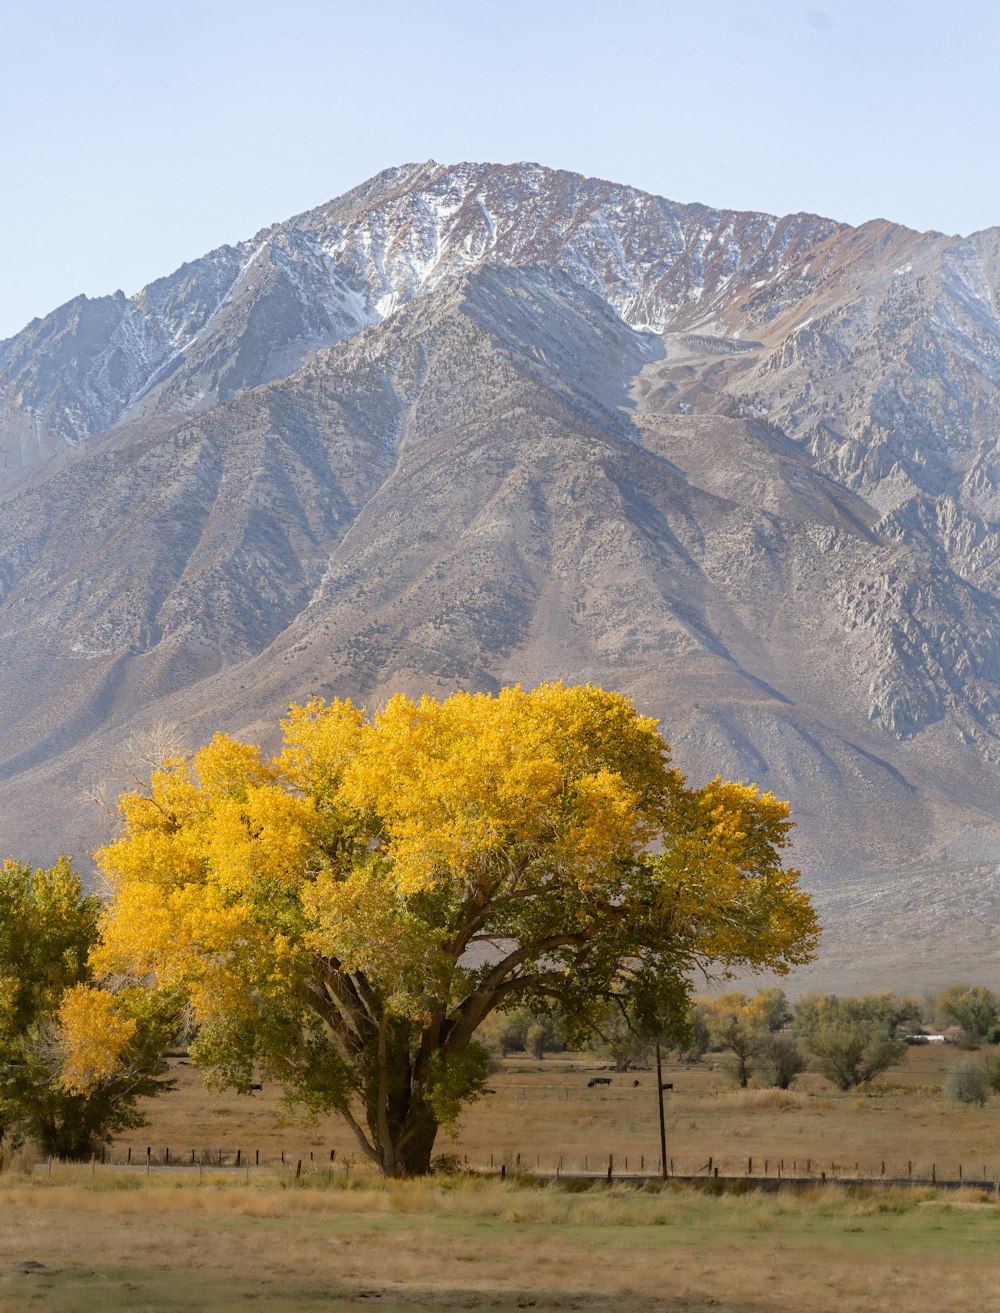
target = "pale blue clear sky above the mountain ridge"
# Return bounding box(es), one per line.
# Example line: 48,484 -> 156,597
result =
0,0 -> 1000,339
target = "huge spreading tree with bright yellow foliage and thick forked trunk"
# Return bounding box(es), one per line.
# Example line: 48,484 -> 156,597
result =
81,684 -> 818,1175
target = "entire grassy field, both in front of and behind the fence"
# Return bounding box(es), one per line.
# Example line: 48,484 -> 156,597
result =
0,1048 -> 1000,1313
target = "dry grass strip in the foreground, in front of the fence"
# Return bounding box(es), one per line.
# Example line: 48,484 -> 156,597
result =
0,1169 -> 1000,1313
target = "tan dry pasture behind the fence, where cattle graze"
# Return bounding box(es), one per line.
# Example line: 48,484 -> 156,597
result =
103,1045 -> 1000,1182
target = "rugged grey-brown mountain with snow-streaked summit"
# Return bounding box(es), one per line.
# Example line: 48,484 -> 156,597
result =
0,161 -> 1000,983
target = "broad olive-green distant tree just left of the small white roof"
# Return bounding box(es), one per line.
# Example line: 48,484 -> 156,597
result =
794,994 -> 907,1090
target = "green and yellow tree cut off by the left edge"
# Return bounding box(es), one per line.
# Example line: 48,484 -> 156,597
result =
0,857 -> 172,1158
